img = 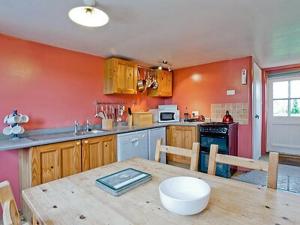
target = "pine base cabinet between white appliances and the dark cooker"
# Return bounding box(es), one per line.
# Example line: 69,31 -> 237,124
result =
167,126 -> 198,164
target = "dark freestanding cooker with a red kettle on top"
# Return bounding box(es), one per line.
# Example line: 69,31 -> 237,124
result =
199,122 -> 238,178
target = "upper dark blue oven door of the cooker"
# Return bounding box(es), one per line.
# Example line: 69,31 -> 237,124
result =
200,133 -> 229,154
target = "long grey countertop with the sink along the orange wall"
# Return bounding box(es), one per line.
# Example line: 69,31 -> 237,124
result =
0,122 -> 203,151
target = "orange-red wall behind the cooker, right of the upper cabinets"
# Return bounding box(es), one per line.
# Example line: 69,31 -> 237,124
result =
167,57 -> 252,157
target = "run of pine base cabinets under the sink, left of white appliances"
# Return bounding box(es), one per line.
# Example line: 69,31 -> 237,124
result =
27,135 -> 117,187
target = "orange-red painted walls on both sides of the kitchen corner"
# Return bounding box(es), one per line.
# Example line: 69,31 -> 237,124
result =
0,34 -> 251,213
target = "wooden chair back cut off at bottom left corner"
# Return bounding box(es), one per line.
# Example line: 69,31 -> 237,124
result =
0,181 -> 21,225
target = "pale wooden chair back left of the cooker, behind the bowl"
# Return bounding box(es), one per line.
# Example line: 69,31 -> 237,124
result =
155,139 -> 200,171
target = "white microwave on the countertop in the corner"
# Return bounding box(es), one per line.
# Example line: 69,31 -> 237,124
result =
158,105 -> 180,123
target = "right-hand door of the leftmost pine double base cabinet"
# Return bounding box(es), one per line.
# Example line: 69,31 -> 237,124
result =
59,141 -> 81,177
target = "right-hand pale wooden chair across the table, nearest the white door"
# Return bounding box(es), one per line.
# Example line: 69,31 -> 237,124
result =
208,145 -> 279,189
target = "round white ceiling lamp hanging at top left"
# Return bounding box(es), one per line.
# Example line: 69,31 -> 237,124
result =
69,0 -> 109,27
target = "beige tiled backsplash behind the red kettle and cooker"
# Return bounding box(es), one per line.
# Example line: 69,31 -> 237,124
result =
211,103 -> 249,125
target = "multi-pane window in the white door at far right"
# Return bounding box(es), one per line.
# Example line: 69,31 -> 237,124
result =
272,79 -> 300,117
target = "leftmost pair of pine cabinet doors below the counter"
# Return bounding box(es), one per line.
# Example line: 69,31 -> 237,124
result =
30,141 -> 81,186
